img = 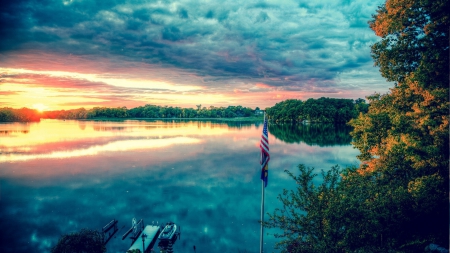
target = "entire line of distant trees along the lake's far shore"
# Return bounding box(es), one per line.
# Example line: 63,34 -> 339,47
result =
0,97 -> 369,123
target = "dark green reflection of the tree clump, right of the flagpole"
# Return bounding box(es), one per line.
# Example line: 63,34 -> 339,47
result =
269,124 -> 352,147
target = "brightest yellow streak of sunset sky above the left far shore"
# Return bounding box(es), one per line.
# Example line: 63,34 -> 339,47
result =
0,68 -> 237,110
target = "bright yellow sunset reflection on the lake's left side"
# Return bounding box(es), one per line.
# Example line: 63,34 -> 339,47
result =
0,120 -> 228,162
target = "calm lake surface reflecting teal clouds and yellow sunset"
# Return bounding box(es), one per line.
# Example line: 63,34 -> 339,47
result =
0,120 -> 358,253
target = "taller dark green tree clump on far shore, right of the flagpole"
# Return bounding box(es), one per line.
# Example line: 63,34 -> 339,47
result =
266,97 -> 369,123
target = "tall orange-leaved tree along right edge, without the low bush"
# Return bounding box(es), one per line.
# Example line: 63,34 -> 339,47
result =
351,0 -> 449,251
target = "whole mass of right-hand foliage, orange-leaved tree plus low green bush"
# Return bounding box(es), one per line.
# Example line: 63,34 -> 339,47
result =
265,0 -> 450,252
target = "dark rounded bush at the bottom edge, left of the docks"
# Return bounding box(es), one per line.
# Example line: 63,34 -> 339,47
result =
52,229 -> 106,253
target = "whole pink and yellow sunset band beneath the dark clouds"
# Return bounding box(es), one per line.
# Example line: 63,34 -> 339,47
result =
0,51 -> 384,110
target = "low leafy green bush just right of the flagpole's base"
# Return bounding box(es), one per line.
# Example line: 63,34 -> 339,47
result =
264,165 -> 345,253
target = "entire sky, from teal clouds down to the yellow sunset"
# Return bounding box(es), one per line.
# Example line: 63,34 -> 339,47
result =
0,0 -> 392,110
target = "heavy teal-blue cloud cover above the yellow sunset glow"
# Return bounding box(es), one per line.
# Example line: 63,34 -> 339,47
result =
0,0 -> 389,107
